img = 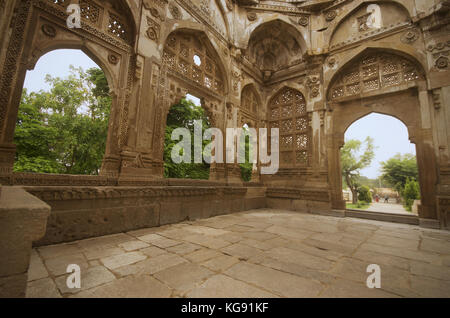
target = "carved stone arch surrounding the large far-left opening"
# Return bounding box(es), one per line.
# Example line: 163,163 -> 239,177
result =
0,0 -> 136,175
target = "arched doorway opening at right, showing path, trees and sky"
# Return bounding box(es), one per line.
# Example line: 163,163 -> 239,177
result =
341,113 -> 420,215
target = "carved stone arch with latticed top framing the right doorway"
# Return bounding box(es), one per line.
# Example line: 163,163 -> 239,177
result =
327,49 -> 438,219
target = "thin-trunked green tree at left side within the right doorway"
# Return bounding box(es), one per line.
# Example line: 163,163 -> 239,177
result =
341,137 -> 375,204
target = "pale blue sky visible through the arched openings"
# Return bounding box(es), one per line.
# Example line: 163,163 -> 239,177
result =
24,50 -> 416,179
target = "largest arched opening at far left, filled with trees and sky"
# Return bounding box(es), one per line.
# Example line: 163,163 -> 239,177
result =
14,49 -> 112,175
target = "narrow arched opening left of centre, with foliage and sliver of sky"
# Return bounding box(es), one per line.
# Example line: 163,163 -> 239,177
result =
164,94 -> 211,180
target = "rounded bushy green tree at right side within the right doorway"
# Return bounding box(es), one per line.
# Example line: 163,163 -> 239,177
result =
381,154 -> 419,196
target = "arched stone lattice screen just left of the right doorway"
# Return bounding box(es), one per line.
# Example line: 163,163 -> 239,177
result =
267,86 -> 311,168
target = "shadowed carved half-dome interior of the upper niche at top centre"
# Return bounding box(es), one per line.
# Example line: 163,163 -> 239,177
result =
246,20 -> 303,72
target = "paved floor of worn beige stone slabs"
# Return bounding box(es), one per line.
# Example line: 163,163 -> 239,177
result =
27,209 -> 450,297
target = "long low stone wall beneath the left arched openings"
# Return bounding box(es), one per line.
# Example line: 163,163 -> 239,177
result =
24,184 -> 266,246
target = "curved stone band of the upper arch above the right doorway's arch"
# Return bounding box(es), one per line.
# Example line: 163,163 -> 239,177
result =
324,0 -> 415,49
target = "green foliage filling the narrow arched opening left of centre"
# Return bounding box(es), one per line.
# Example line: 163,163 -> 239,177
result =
164,99 -> 210,180
